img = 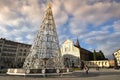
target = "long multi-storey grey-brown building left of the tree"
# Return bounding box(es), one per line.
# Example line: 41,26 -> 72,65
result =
0,38 -> 31,68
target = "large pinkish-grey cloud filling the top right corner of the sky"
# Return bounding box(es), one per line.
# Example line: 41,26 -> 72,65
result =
64,0 -> 120,25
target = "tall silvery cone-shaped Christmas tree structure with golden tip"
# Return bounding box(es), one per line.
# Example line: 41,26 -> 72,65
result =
23,3 -> 64,69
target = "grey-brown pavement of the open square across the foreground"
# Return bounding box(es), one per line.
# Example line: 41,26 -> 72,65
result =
0,69 -> 120,80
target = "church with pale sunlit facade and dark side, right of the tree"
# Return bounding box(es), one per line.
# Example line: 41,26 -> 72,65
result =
61,39 -> 93,67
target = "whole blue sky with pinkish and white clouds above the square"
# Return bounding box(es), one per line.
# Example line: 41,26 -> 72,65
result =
0,0 -> 120,58
